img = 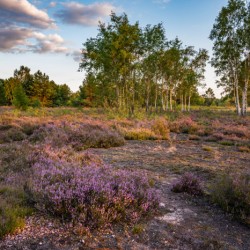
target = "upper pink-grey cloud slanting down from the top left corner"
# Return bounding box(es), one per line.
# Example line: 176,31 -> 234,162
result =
0,0 -> 55,29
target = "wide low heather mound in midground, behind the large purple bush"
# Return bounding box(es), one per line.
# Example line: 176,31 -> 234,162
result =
30,122 -> 124,150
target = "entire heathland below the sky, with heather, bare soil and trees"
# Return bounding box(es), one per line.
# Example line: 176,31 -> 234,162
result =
0,0 -> 250,249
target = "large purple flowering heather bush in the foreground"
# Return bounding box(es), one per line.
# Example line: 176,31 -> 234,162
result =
30,155 -> 159,228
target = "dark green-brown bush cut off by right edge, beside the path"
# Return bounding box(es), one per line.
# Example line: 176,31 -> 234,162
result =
210,174 -> 250,225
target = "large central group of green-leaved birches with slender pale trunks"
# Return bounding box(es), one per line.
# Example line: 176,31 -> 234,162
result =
80,13 -> 208,113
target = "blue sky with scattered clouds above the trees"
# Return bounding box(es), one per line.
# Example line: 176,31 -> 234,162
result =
0,0 -> 227,97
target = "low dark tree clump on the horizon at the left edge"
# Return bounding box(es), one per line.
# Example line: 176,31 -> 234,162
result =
0,66 -> 73,109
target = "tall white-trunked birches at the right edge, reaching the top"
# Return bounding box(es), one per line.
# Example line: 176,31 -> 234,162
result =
210,0 -> 250,115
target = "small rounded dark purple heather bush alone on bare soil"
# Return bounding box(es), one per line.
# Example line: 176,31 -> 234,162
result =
172,173 -> 203,196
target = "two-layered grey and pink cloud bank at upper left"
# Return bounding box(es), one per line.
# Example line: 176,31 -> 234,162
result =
0,0 -> 68,53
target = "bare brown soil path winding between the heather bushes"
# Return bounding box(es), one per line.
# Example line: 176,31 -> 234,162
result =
0,135 -> 250,250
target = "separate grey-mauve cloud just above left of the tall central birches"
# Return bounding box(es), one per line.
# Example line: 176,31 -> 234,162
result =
56,2 -> 116,26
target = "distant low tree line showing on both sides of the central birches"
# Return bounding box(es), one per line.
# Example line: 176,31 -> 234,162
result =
0,66 -> 220,110
